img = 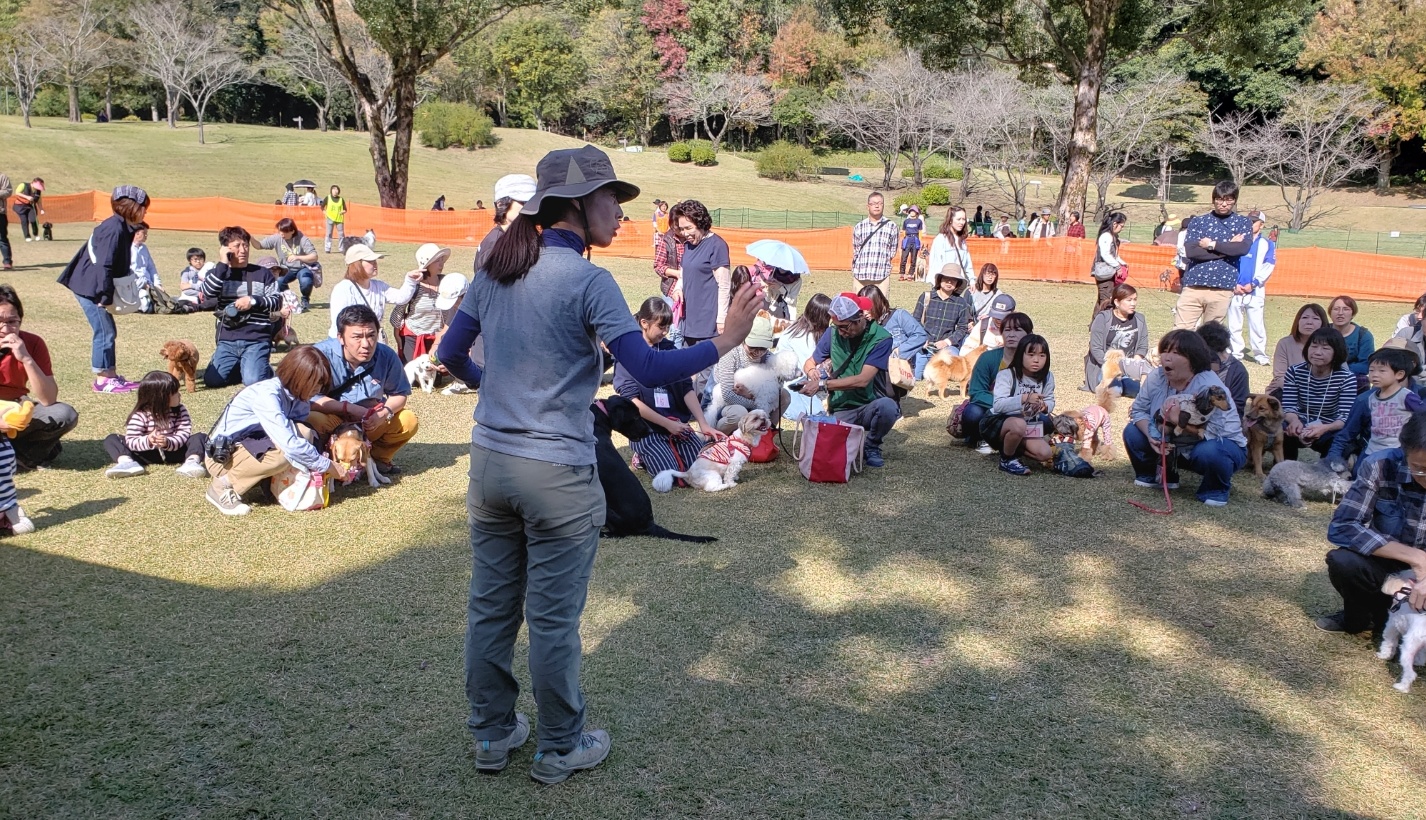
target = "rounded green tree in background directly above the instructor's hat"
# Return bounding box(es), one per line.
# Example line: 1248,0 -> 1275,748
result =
491,17 -> 585,131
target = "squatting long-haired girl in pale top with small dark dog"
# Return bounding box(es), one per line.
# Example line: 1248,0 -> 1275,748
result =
981,334 -> 1055,475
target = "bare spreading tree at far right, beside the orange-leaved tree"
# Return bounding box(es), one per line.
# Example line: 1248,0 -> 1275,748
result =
1249,83 -> 1383,231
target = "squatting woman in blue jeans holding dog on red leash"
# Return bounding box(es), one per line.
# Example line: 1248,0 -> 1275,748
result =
1124,329 -> 1248,506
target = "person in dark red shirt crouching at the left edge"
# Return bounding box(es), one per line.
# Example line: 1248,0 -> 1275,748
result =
0,285 -> 80,471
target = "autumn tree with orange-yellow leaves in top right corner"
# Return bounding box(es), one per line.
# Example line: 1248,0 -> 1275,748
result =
1302,0 -> 1426,195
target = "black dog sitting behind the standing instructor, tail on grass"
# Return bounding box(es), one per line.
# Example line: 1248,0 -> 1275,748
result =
589,396 -> 717,543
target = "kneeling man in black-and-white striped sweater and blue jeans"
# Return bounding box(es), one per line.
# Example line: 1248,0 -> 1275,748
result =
202,225 -> 284,388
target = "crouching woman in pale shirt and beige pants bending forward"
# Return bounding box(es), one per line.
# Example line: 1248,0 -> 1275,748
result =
205,345 -> 341,515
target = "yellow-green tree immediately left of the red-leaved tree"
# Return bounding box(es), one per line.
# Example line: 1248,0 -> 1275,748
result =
580,9 -> 663,145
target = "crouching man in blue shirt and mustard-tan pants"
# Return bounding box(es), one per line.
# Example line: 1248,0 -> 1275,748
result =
307,305 -> 421,475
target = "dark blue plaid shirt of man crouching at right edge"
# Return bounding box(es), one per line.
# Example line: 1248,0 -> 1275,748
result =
1328,448 -> 1426,555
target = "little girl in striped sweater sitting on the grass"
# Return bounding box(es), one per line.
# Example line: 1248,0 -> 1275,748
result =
104,371 -> 208,478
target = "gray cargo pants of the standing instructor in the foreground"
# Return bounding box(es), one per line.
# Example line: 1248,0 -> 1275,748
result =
465,445 -> 605,753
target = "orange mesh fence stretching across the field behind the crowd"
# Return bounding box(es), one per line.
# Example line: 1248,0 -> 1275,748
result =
44,191 -> 1426,301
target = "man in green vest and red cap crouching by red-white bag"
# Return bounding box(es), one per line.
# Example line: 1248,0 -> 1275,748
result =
801,294 -> 901,468
